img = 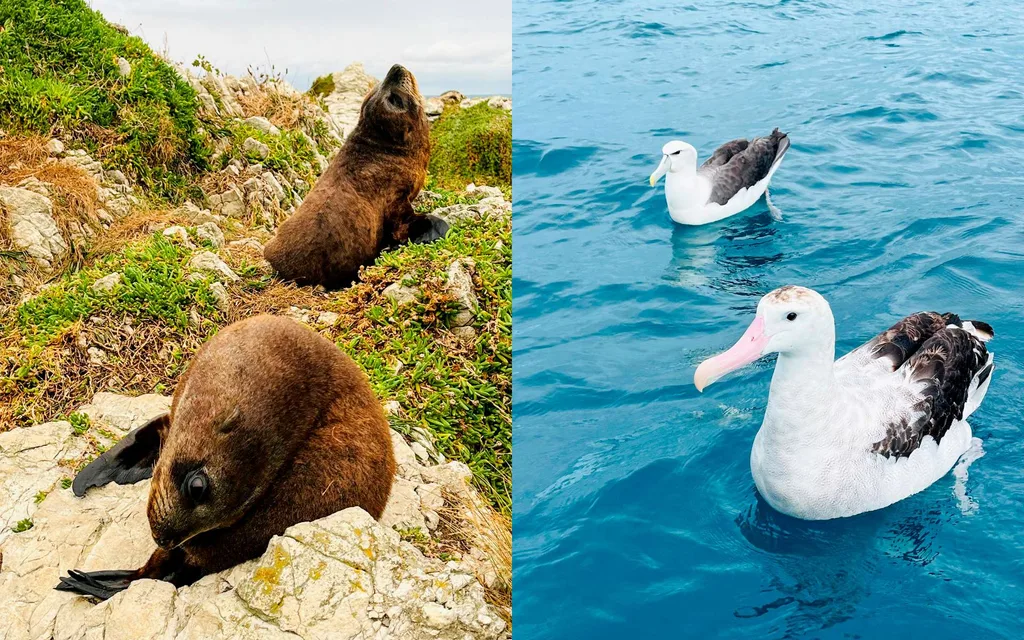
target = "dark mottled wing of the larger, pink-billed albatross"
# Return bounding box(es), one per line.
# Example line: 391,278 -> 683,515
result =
851,313 -> 992,458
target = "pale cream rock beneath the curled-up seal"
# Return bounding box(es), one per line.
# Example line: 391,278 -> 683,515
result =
0,393 -> 508,640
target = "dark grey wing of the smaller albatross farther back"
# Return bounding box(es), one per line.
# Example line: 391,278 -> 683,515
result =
698,129 -> 790,205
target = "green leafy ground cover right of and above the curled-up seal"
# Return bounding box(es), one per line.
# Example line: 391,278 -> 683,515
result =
337,194 -> 512,512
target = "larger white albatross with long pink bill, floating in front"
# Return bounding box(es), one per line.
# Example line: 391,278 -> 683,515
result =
693,287 -> 992,520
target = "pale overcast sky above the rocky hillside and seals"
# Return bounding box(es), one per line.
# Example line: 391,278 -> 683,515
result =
89,0 -> 512,95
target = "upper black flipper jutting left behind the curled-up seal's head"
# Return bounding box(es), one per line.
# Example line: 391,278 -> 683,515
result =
71,414 -> 171,498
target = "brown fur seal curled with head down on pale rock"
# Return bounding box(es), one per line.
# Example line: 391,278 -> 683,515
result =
56,315 -> 395,599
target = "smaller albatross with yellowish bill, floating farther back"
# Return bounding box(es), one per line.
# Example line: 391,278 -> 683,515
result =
650,129 -> 790,224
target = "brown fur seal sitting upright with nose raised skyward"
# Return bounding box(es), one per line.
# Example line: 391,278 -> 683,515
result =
263,65 -> 447,289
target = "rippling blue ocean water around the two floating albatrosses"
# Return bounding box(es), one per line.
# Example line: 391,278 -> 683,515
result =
513,0 -> 1024,640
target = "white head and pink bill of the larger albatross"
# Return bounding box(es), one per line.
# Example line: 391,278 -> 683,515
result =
693,286 -> 836,391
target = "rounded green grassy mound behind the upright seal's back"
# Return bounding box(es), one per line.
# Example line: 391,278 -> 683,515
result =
430,102 -> 512,189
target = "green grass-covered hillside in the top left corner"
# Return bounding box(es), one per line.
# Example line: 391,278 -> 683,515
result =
0,0 -> 210,200
